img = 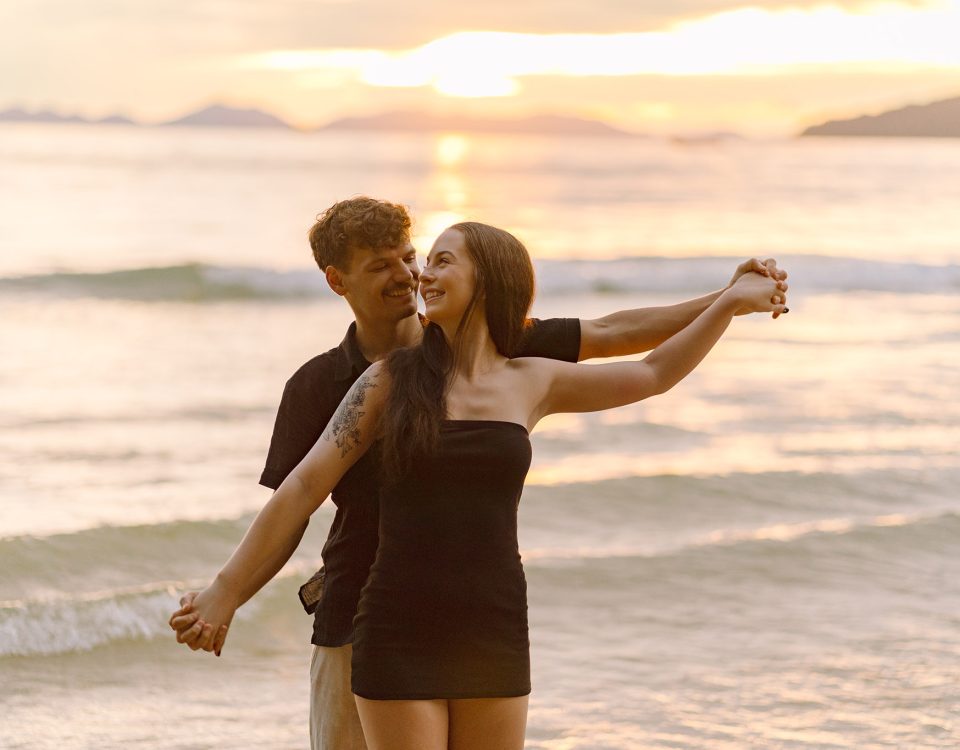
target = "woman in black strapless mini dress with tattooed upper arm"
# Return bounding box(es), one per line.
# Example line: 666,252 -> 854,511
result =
182,222 -> 785,750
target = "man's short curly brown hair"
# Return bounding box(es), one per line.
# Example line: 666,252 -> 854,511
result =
308,195 -> 410,271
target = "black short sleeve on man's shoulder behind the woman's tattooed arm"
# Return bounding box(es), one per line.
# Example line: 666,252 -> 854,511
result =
260,368 -> 340,490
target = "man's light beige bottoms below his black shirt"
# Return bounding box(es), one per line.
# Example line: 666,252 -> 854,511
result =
310,644 -> 367,750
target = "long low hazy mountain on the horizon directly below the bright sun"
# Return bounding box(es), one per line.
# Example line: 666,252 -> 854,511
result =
319,112 -> 634,137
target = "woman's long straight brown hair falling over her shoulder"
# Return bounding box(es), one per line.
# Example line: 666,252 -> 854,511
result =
381,221 -> 534,481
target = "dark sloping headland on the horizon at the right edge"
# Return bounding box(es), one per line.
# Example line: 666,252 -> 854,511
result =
801,96 -> 960,138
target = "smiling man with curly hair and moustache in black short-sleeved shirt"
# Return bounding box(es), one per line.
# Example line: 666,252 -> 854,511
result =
170,197 -> 786,750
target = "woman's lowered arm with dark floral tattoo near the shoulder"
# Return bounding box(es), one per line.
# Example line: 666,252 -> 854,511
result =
178,364 -> 389,653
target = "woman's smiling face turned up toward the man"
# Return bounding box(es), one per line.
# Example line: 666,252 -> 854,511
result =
420,229 -> 477,325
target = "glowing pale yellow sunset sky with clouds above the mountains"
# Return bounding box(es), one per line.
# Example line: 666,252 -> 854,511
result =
7,0 -> 960,135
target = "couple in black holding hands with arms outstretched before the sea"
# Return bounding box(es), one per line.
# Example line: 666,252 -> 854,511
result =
170,198 -> 786,750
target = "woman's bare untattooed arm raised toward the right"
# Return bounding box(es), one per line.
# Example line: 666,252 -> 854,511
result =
531,273 -> 783,423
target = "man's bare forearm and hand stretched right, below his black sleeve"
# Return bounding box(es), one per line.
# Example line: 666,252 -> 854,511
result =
579,258 -> 787,361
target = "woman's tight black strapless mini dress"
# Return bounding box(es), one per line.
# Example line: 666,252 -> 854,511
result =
353,420 -> 531,700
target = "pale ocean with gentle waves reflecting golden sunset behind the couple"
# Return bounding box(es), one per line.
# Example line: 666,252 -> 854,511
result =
0,125 -> 960,750
